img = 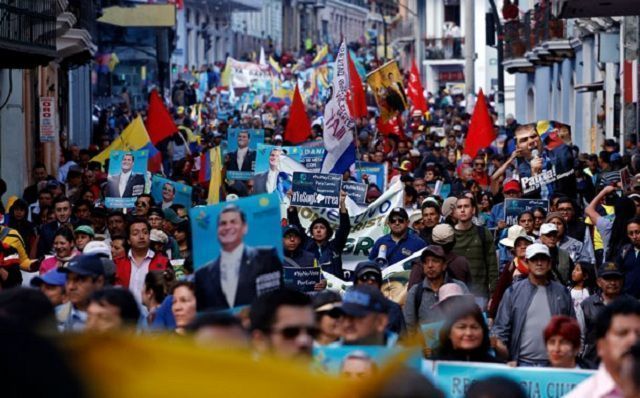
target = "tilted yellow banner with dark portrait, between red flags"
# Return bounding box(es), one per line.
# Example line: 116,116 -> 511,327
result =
367,61 -> 408,123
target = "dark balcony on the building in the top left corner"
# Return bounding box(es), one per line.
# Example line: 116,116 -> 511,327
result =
0,0 -> 57,68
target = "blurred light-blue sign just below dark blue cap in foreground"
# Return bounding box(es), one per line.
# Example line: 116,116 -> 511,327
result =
312,345 -> 422,375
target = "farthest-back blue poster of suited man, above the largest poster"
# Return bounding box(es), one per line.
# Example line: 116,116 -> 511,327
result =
224,128 -> 264,180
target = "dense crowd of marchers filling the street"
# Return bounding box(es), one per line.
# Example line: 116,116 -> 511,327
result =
0,48 -> 640,397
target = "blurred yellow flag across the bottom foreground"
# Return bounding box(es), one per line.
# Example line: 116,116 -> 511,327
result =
63,334 -> 364,398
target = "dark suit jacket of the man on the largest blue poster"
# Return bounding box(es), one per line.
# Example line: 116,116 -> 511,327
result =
195,246 -> 282,311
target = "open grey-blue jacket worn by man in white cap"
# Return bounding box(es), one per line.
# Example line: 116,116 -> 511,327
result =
491,279 -> 575,361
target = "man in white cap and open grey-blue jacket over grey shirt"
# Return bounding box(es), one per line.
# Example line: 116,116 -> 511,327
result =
491,243 -> 575,366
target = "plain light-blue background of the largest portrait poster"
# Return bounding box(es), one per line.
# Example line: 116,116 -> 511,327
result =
189,193 -> 283,269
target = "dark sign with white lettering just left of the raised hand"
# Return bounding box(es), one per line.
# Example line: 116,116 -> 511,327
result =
291,172 -> 342,209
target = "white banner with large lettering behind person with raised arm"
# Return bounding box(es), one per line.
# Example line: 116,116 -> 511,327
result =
298,181 -> 404,280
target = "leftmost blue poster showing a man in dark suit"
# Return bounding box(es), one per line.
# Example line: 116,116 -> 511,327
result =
105,150 -> 149,209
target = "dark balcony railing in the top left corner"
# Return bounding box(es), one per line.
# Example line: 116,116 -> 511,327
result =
0,0 -> 56,55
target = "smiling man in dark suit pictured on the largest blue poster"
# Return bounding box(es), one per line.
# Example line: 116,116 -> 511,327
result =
195,204 -> 282,311
